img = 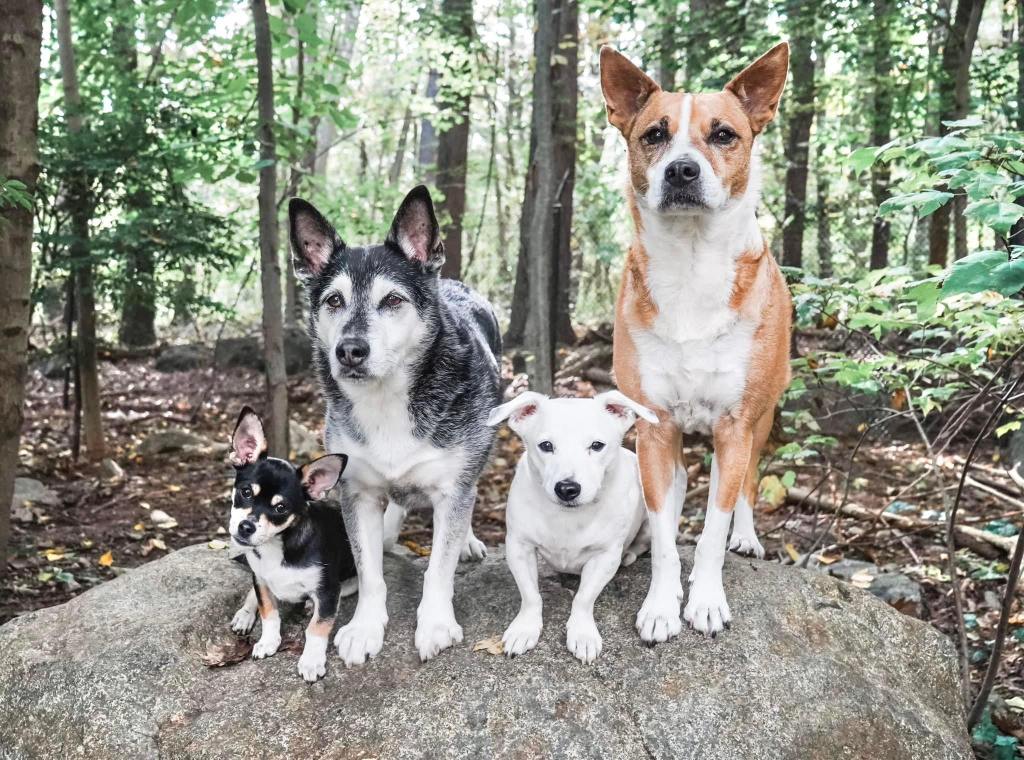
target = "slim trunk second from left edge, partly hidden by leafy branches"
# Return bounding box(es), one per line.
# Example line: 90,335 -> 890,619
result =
56,0 -> 104,460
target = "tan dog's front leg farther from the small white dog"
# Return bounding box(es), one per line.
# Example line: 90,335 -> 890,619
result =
683,417 -> 754,636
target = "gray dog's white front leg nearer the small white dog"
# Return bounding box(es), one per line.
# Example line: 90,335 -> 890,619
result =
416,491 -> 475,662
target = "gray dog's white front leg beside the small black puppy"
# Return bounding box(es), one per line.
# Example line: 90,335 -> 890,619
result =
334,494 -> 388,666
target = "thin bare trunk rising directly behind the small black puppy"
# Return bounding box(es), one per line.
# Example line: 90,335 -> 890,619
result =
252,0 -> 289,457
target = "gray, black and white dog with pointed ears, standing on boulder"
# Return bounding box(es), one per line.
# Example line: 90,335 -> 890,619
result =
289,185 -> 501,665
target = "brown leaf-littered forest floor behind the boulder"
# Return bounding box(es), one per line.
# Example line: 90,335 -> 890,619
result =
0,338 -> 1024,738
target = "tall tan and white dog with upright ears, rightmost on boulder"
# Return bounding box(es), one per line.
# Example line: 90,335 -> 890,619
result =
601,43 -> 792,642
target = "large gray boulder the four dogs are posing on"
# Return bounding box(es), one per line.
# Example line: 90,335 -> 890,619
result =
0,546 -> 973,760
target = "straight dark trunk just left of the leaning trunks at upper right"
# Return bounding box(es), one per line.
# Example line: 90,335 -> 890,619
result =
870,0 -> 893,269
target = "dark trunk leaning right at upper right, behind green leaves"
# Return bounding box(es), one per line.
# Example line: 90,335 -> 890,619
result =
928,0 -> 985,266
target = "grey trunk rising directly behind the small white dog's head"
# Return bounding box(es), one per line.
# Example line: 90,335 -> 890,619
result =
526,0 -> 558,394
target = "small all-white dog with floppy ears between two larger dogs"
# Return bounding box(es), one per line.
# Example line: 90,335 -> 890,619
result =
487,390 -> 657,663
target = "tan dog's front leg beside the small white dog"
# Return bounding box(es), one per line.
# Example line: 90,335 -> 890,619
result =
637,415 -> 686,643
